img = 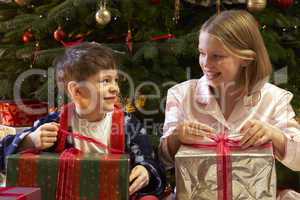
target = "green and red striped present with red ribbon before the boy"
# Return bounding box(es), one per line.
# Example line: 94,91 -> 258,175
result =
6,149 -> 129,200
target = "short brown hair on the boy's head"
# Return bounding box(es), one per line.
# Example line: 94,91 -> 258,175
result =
53,42 -> 117,89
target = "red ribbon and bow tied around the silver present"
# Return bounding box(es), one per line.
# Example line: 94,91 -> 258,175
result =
191,133 -> 272,200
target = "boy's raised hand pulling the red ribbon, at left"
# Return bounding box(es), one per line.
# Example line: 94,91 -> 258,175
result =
28,122 -> 59,149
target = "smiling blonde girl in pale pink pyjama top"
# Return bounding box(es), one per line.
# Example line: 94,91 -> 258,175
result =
159,10 -> 300,170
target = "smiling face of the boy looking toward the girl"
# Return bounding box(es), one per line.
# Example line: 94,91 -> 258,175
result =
69,69 -> 119,116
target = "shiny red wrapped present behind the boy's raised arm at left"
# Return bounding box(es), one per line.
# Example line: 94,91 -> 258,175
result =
0,100 -> 48,127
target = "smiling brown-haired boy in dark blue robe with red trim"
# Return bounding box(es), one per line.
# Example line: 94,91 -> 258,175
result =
1,42 -> 165,199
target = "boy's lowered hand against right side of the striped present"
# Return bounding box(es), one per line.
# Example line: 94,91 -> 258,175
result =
129,165 -> 150,195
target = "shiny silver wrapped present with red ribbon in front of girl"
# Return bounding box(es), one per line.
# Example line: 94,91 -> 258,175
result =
175,135 -> 276,200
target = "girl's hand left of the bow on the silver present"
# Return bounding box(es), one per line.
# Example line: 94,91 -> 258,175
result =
176,121 -> 215,144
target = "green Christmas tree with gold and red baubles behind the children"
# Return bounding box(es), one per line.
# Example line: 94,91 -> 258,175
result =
0,0 -> 300,189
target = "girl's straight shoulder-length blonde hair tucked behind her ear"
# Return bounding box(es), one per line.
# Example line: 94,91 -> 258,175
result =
200,10 -> 272,95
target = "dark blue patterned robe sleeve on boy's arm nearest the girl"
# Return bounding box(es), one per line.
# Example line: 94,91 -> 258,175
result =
125,114 -> 166,196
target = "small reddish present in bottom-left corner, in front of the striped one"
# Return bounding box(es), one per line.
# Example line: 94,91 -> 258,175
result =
0,187 -> 41,200
